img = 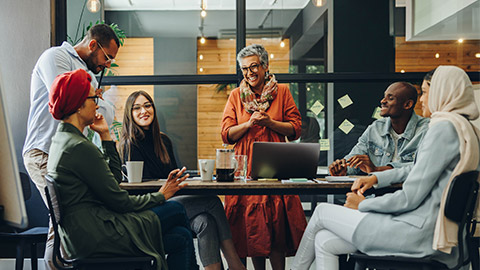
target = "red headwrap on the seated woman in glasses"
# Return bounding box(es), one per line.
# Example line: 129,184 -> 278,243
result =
48,69 -> 92,120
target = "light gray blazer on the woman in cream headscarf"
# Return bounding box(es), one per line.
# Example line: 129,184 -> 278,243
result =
353,121 -> 474,266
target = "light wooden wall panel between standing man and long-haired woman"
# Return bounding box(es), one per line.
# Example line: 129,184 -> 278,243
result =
105,38 -> 154,122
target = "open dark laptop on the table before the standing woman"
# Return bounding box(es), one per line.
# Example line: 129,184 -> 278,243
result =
251,142 -> 320,179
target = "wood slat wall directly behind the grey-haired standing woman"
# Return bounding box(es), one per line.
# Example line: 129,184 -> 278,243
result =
197,39 -> 290,159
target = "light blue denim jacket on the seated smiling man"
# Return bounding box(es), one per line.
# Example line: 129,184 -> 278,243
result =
345,112 -> 430,174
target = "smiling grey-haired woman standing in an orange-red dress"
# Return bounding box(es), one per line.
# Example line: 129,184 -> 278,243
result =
222,45 -> 307,270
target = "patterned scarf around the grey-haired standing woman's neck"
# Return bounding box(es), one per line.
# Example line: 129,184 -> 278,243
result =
240,74 -> 278,113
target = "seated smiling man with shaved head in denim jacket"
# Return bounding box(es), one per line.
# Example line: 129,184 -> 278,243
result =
328,82 -> 429,175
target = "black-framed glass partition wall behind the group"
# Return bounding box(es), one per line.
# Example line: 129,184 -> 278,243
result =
63,0 -> 480,169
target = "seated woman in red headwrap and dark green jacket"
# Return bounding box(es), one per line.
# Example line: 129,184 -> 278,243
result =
47,69 -> 198,269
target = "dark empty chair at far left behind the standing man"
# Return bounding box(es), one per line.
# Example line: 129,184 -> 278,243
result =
0,173 -> 48,270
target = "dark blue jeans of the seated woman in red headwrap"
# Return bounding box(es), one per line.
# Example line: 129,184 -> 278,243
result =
150,201 -> 198,270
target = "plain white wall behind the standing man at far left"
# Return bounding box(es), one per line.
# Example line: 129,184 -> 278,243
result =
0,0 -> 51,171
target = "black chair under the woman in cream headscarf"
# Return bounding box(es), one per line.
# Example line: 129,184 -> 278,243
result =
350,171 -> 480,270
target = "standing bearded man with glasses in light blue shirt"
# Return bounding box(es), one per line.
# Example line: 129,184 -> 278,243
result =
23,24 -> 120,269
